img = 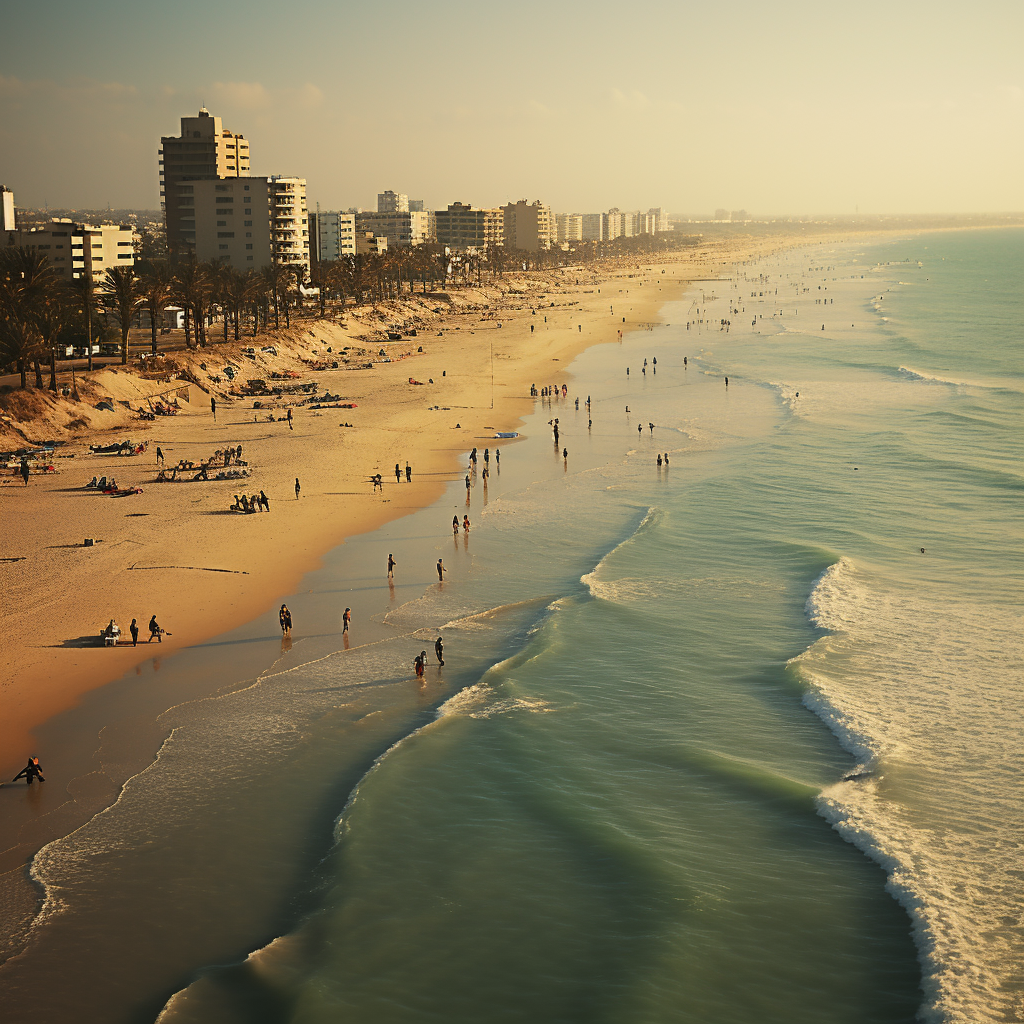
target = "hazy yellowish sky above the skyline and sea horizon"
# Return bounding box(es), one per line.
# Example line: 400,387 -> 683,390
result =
0,0 -> 1024,214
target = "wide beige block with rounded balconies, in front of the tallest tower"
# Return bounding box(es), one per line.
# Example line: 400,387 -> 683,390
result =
184,175 -> 309,273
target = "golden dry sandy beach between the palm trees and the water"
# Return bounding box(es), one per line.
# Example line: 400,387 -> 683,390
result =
0,239 -> 798,770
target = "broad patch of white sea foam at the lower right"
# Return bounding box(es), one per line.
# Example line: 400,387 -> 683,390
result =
792,558 -> 1024,1024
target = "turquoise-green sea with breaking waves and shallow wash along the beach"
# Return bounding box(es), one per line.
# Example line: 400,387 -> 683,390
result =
0,229 -> 1024,1024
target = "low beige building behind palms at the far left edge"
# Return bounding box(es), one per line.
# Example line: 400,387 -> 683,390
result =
0,217 -> 137,285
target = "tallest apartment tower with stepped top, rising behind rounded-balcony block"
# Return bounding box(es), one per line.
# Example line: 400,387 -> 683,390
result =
160,106 -> 249,256
